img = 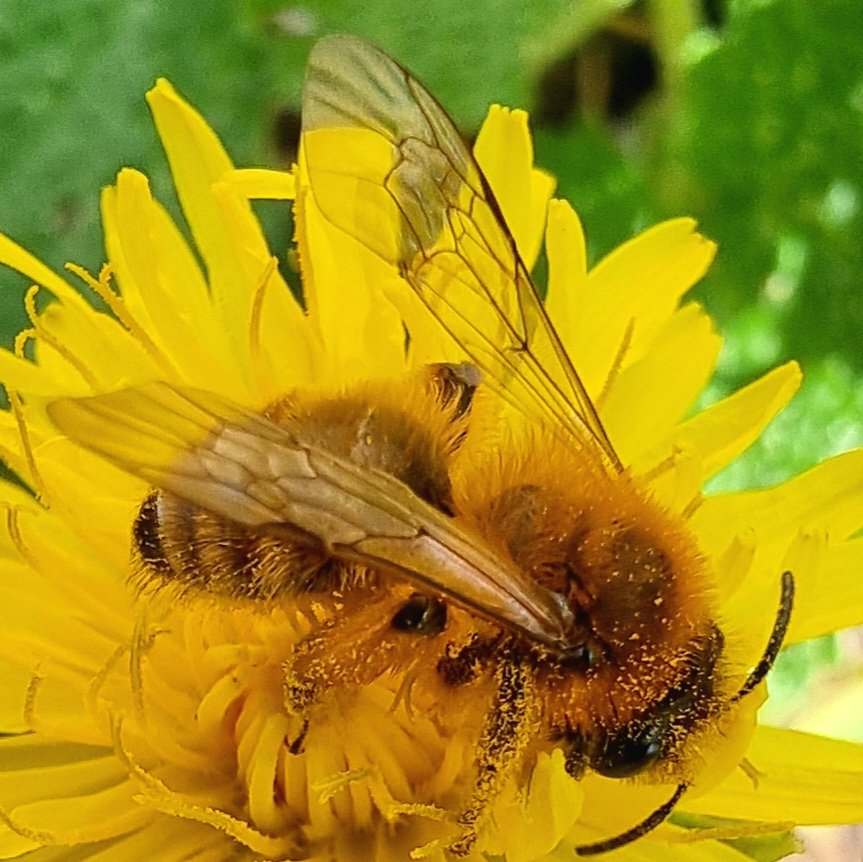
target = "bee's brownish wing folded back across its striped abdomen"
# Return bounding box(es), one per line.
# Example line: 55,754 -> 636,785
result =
48,383 -> 584,651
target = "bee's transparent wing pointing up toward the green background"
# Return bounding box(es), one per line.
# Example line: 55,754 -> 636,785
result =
302,36 -> 622,470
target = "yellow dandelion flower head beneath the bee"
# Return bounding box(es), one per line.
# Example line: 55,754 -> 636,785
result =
0,44 -> 863,862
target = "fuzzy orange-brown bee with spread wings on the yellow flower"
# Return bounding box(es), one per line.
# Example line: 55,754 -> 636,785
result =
49,36 -> 794,856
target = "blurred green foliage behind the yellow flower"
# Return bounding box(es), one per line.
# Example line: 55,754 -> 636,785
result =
0,0 -> 863,852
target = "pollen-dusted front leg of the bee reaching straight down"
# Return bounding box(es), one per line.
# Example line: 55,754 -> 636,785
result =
447,656 -> 538,856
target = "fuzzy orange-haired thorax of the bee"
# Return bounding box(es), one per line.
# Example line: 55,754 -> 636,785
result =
453,427 -> 716,712
